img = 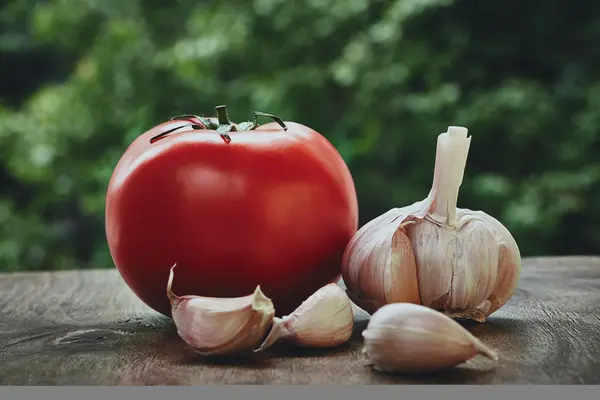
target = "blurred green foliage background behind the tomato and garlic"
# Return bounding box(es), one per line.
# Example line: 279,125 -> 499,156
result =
0,0 -> 600,271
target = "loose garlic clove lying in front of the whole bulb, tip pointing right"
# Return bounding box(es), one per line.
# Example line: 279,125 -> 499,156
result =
362,303 -> 498,373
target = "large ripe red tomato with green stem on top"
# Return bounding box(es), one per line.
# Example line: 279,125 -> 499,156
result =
105,106 -> 358,316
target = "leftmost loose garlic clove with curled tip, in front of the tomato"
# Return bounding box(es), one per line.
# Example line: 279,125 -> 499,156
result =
167,266 -> 275,356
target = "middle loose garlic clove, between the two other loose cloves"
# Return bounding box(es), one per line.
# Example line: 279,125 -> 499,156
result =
257,283 -> 354,351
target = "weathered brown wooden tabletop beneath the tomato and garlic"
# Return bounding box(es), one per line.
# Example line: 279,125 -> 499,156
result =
0,257 -> 600,385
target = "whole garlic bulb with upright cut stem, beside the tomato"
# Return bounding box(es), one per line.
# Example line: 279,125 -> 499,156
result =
342,126 -> 521,322
